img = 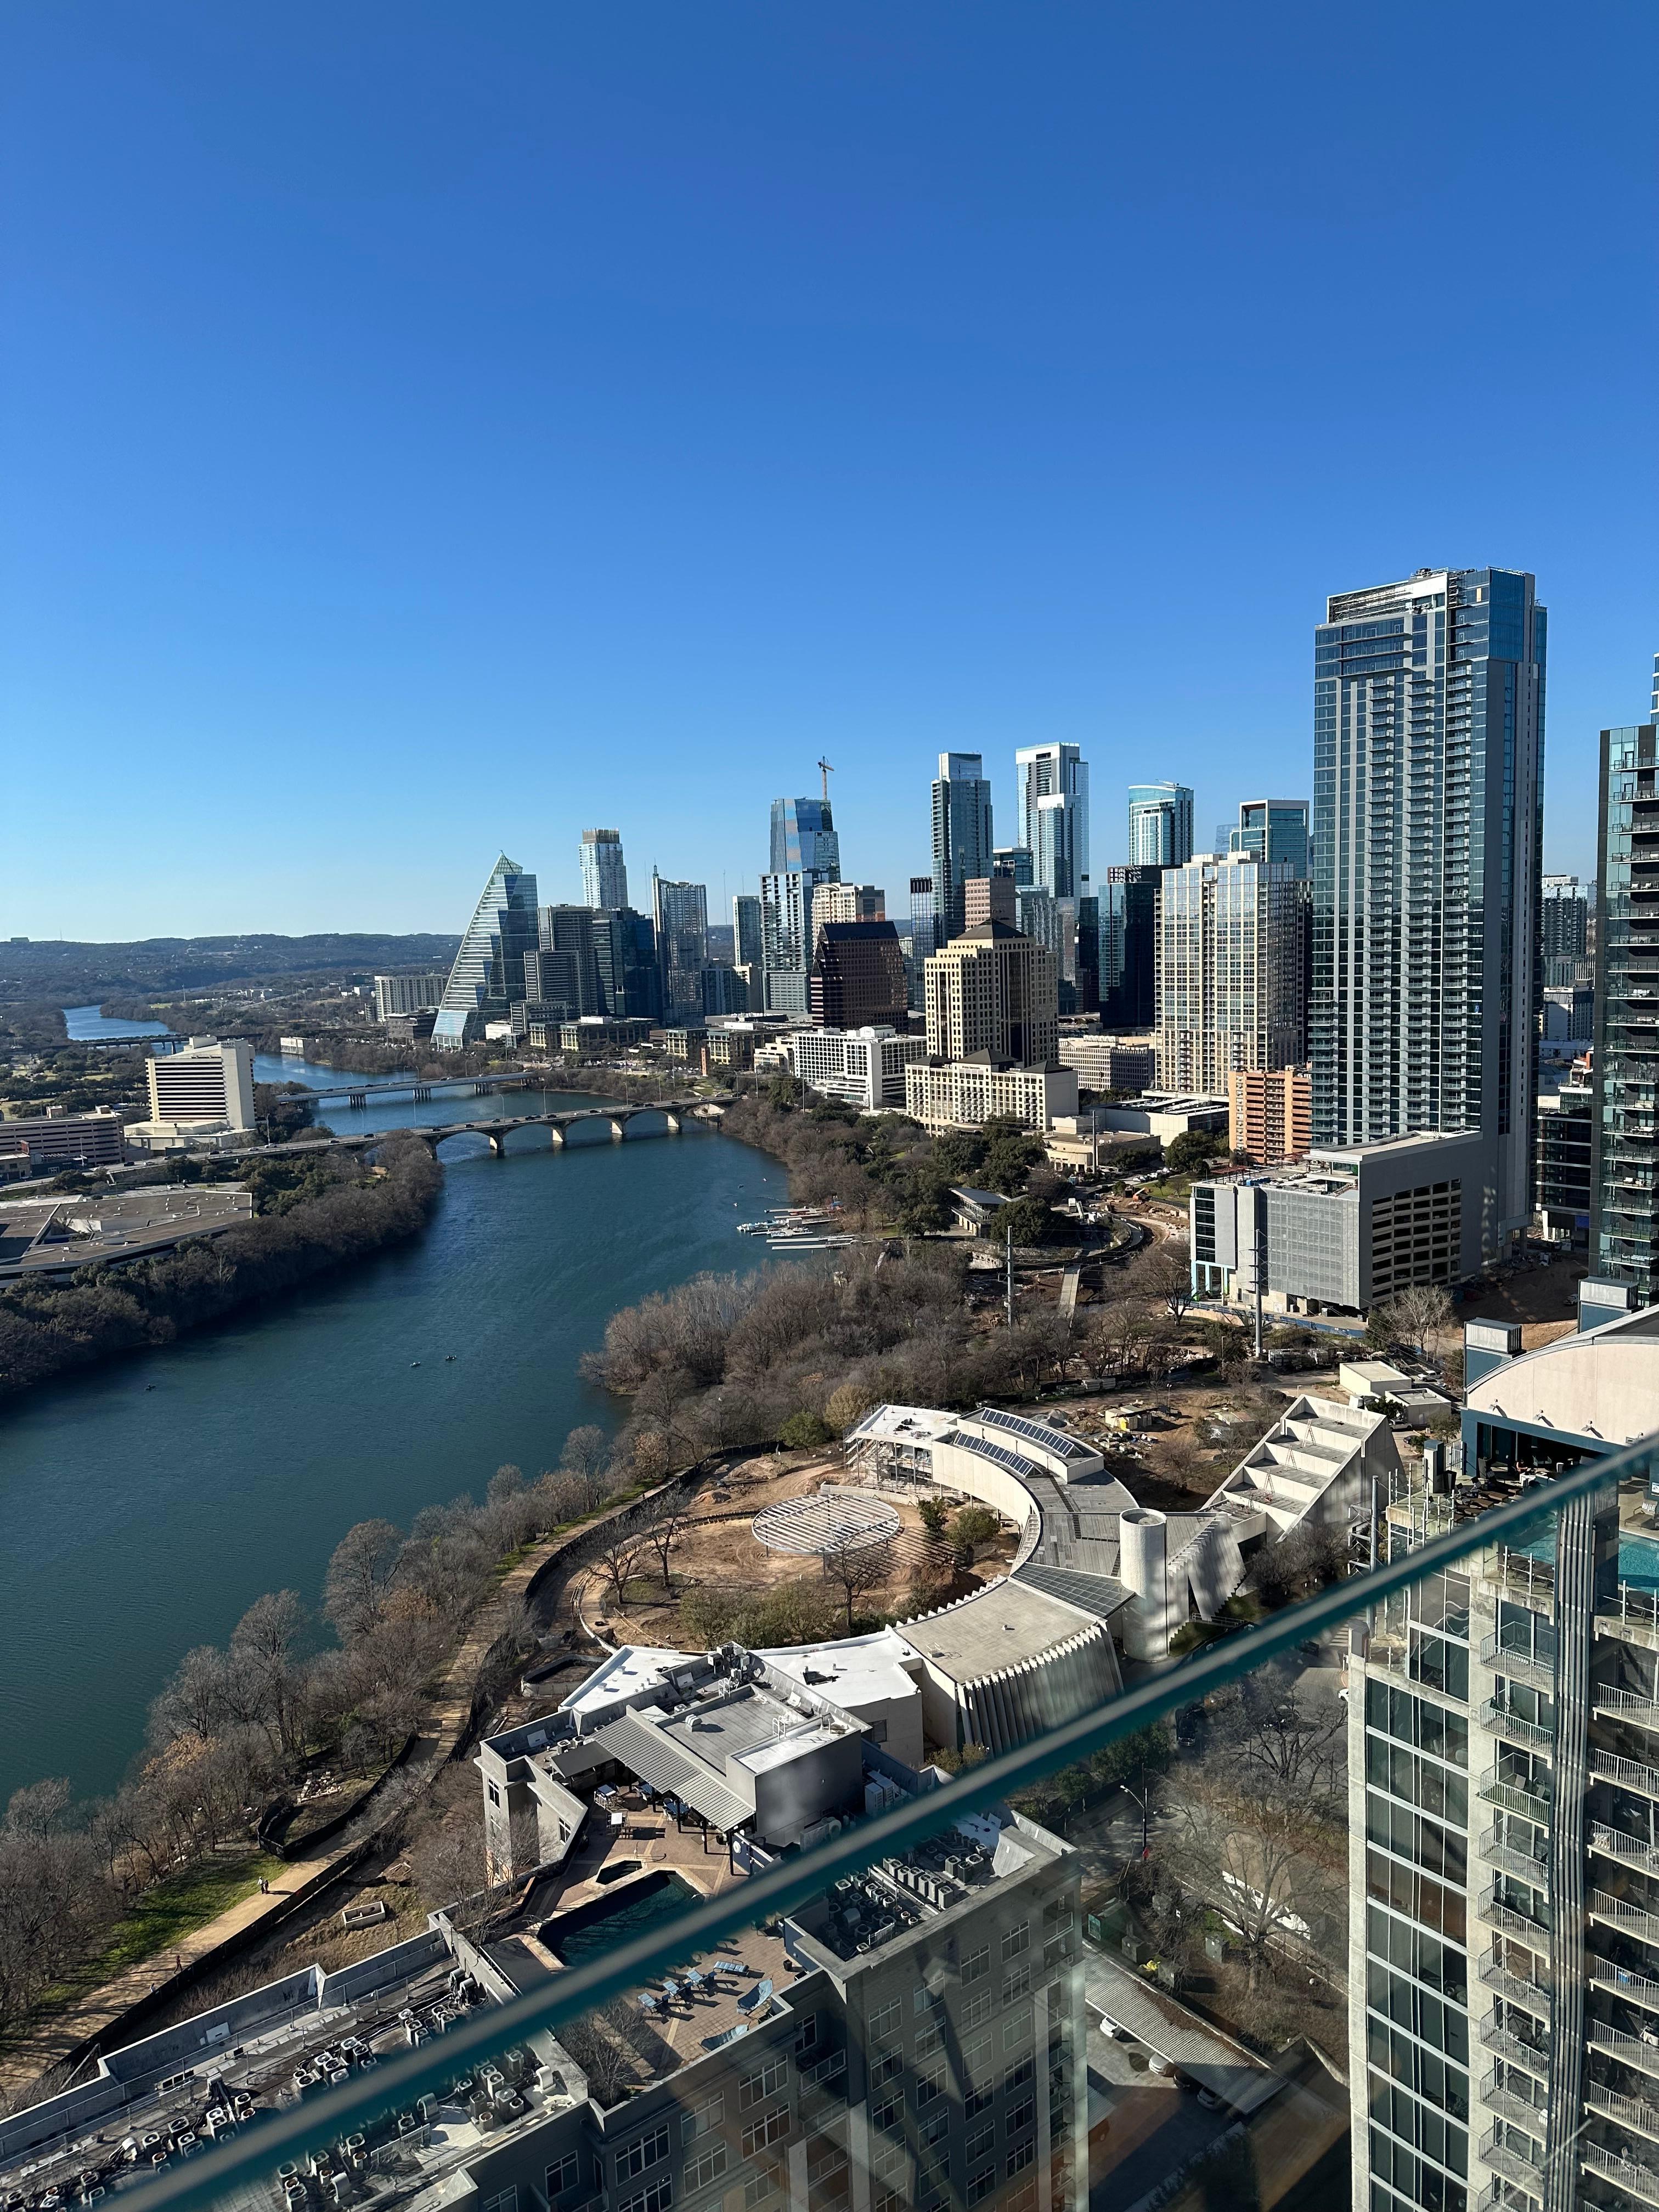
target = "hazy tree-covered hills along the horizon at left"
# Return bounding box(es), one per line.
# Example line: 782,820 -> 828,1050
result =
0,934 -> 460,1007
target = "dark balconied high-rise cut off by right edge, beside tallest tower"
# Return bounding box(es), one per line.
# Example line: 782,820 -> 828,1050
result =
1590,721 -> 1659,1305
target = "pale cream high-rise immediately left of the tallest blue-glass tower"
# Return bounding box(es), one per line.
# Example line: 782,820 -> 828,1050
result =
1157,854 -> 1307,1093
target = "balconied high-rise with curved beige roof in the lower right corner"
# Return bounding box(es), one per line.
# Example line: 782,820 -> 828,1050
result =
1347,1285 -> 1659,2212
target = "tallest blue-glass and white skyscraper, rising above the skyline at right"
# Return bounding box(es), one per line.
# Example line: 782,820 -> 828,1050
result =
1310,568 -> 1546,1256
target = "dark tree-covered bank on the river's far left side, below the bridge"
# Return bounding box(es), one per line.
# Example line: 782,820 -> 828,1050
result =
0,1139 -> 442,1398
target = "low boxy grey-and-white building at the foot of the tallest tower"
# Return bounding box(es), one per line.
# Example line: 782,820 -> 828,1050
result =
1188,1130 -> 1484,1314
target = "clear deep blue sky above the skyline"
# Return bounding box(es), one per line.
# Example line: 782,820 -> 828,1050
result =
0,0 -> 1659,938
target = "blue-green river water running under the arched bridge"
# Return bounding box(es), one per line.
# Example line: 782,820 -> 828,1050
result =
0,1057 -> 787,1803
